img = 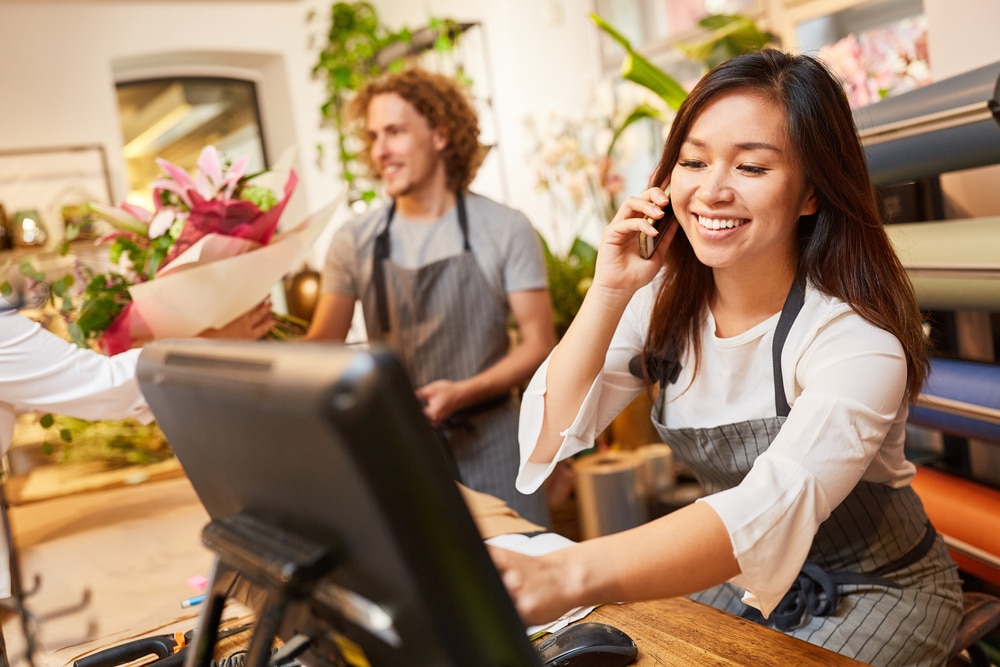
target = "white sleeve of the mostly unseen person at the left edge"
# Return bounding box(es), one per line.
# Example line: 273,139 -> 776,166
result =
0,311 -> 153,454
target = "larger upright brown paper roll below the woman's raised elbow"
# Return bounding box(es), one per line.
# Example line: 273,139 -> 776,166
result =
573,451 -> 649,540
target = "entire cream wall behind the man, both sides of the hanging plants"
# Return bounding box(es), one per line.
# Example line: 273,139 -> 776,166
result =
0,0 -> 599,266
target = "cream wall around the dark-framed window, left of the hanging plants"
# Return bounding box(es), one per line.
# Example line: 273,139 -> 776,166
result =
0,0 -> 333,239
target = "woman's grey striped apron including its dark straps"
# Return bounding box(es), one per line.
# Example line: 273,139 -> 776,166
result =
652,279 -> 962,667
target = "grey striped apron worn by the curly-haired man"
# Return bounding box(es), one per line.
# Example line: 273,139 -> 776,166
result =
362,193 -> 549,526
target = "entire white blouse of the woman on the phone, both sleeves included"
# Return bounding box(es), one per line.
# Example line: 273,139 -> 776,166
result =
517,284 -> 915,615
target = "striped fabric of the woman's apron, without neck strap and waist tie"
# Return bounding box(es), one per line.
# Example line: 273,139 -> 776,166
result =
658,414 -> 962,667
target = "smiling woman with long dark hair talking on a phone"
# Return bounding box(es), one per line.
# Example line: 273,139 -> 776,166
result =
494,50 -> 962,665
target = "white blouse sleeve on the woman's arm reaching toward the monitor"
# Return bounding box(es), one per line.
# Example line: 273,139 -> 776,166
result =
702,315 -> 906,616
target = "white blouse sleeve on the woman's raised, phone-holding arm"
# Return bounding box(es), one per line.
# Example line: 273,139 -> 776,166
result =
515,285 -> 653,493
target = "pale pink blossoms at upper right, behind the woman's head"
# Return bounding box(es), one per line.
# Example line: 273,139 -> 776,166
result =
820,14 -> 931,109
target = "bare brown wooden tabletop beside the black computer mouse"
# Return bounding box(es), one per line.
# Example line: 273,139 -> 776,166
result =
586,598 -> 864,667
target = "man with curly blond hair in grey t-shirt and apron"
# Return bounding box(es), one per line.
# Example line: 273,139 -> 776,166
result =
306,69 -> 555,526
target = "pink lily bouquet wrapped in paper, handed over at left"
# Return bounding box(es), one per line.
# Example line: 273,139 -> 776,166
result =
51,146 -> 297,354
